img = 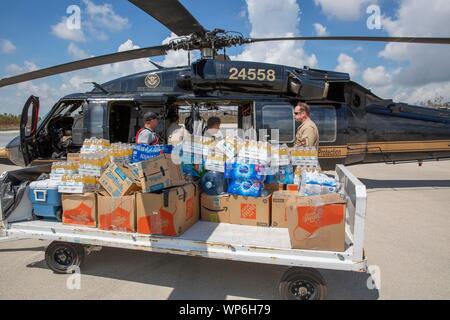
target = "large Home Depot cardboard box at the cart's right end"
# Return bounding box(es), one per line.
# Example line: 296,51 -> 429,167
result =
287,193 -> 345,252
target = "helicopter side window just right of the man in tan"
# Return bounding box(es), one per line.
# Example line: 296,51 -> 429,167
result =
311,105 -> 337,143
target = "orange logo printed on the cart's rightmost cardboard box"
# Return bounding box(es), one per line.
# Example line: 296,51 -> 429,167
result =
297,204 -> 344,233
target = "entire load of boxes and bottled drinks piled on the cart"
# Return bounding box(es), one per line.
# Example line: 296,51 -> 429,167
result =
26,132 -> 345,251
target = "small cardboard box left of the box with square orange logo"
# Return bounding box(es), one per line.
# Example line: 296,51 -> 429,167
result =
200,193 -> 231,223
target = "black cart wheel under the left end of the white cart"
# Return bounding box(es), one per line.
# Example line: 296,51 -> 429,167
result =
45,241 -> 84,273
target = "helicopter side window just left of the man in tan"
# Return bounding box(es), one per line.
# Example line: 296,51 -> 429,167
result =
262,104 -> 295,143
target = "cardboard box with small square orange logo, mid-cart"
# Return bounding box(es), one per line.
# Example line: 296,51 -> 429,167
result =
230,195 -> 271,227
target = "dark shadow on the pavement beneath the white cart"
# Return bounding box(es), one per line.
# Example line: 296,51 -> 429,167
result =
27,248 -> 379,300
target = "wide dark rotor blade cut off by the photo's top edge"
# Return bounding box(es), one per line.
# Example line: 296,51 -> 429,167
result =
128,0 -> 205,36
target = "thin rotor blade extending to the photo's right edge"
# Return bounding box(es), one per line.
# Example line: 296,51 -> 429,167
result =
249,36 -> 450,44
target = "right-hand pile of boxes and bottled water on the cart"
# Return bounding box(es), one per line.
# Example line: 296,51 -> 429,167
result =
178,133 -> 345,251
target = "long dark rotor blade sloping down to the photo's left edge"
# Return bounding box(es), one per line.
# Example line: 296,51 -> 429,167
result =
0,45 -> 170,88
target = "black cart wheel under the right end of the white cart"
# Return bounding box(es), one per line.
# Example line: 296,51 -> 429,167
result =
279,268 -> 328,300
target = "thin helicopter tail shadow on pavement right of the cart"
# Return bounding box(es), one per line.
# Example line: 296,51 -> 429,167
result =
359,178 -> 450,189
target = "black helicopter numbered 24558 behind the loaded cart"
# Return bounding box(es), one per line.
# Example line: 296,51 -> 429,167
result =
0,0 -> 450,169
